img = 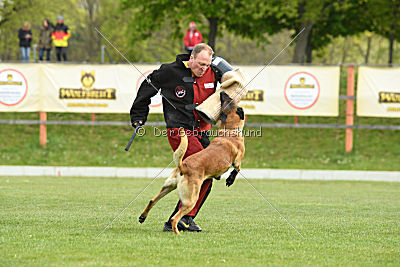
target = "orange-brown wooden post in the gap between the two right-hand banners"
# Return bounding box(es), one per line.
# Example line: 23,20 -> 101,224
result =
346,65 -> 354,153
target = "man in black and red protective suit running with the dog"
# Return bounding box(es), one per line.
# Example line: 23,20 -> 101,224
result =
130,43 -> 221,232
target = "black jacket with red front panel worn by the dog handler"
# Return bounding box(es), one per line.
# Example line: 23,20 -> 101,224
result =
130,54 -> 221,131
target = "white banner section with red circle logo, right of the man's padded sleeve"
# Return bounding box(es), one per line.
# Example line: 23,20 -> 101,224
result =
240,66 -> 340,116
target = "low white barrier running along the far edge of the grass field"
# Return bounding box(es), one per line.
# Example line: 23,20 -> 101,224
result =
0,166 -> 400,182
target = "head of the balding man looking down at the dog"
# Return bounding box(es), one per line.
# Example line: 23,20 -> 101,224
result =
188,43 -> 214,77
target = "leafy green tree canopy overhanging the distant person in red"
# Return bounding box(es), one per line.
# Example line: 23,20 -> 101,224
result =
121,0 -> 277,49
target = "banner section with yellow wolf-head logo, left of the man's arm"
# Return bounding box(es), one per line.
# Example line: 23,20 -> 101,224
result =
41,64 -> 162,113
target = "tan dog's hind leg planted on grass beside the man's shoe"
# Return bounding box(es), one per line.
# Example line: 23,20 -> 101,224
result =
171,181 -> 201,235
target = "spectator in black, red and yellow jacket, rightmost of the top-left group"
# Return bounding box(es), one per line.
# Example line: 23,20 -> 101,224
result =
51,15 -> 71,61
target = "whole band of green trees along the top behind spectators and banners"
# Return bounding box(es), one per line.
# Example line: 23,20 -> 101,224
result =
0,0 -> 400,64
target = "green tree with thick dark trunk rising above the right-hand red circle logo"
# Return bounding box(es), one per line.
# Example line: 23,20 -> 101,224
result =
275,0 -> 368,63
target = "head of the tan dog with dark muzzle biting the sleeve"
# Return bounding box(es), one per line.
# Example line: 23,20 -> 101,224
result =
220,91 -> 244,130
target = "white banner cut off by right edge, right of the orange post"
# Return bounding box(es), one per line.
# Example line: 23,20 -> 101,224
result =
357,66 -> 400,118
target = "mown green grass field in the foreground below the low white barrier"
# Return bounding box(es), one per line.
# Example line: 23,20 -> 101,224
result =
0,177 -> 400,266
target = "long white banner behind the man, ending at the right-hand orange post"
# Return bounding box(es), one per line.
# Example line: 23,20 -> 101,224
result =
0,64 -> 339,116
